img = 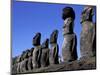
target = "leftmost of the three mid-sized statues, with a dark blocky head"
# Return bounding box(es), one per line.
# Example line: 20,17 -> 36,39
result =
32,33 -> 41,69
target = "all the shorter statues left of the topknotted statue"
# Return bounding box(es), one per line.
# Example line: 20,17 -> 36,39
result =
12,30 -> 59,73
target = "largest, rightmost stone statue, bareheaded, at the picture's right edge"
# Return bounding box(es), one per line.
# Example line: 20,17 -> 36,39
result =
80,6 -> 96,57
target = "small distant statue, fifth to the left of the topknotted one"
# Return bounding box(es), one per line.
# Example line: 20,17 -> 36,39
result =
20,49 -> 29,72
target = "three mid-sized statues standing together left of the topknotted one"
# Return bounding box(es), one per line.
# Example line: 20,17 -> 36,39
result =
32,30 -> 59,68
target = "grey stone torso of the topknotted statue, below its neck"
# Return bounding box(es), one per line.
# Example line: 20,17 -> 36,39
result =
62,34 -> 77,62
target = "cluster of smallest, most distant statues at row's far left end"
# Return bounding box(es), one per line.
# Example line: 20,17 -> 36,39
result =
12,48 -> 34,73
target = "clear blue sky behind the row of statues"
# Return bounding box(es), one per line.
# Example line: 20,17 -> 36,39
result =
12,1 -> 95,57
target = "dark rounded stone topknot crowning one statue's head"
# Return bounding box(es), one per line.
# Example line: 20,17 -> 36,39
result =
62,7 -> 75,20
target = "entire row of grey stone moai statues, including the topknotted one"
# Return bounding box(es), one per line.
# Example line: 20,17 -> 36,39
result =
12,6 -> 96,72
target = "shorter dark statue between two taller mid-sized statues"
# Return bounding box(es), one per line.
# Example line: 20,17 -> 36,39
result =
41,39 -> 49,67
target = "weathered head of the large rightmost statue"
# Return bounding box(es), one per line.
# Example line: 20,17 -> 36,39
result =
81,6 -> 93,23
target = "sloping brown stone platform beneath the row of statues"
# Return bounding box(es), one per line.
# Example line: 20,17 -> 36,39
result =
14,57 -> 96,74
